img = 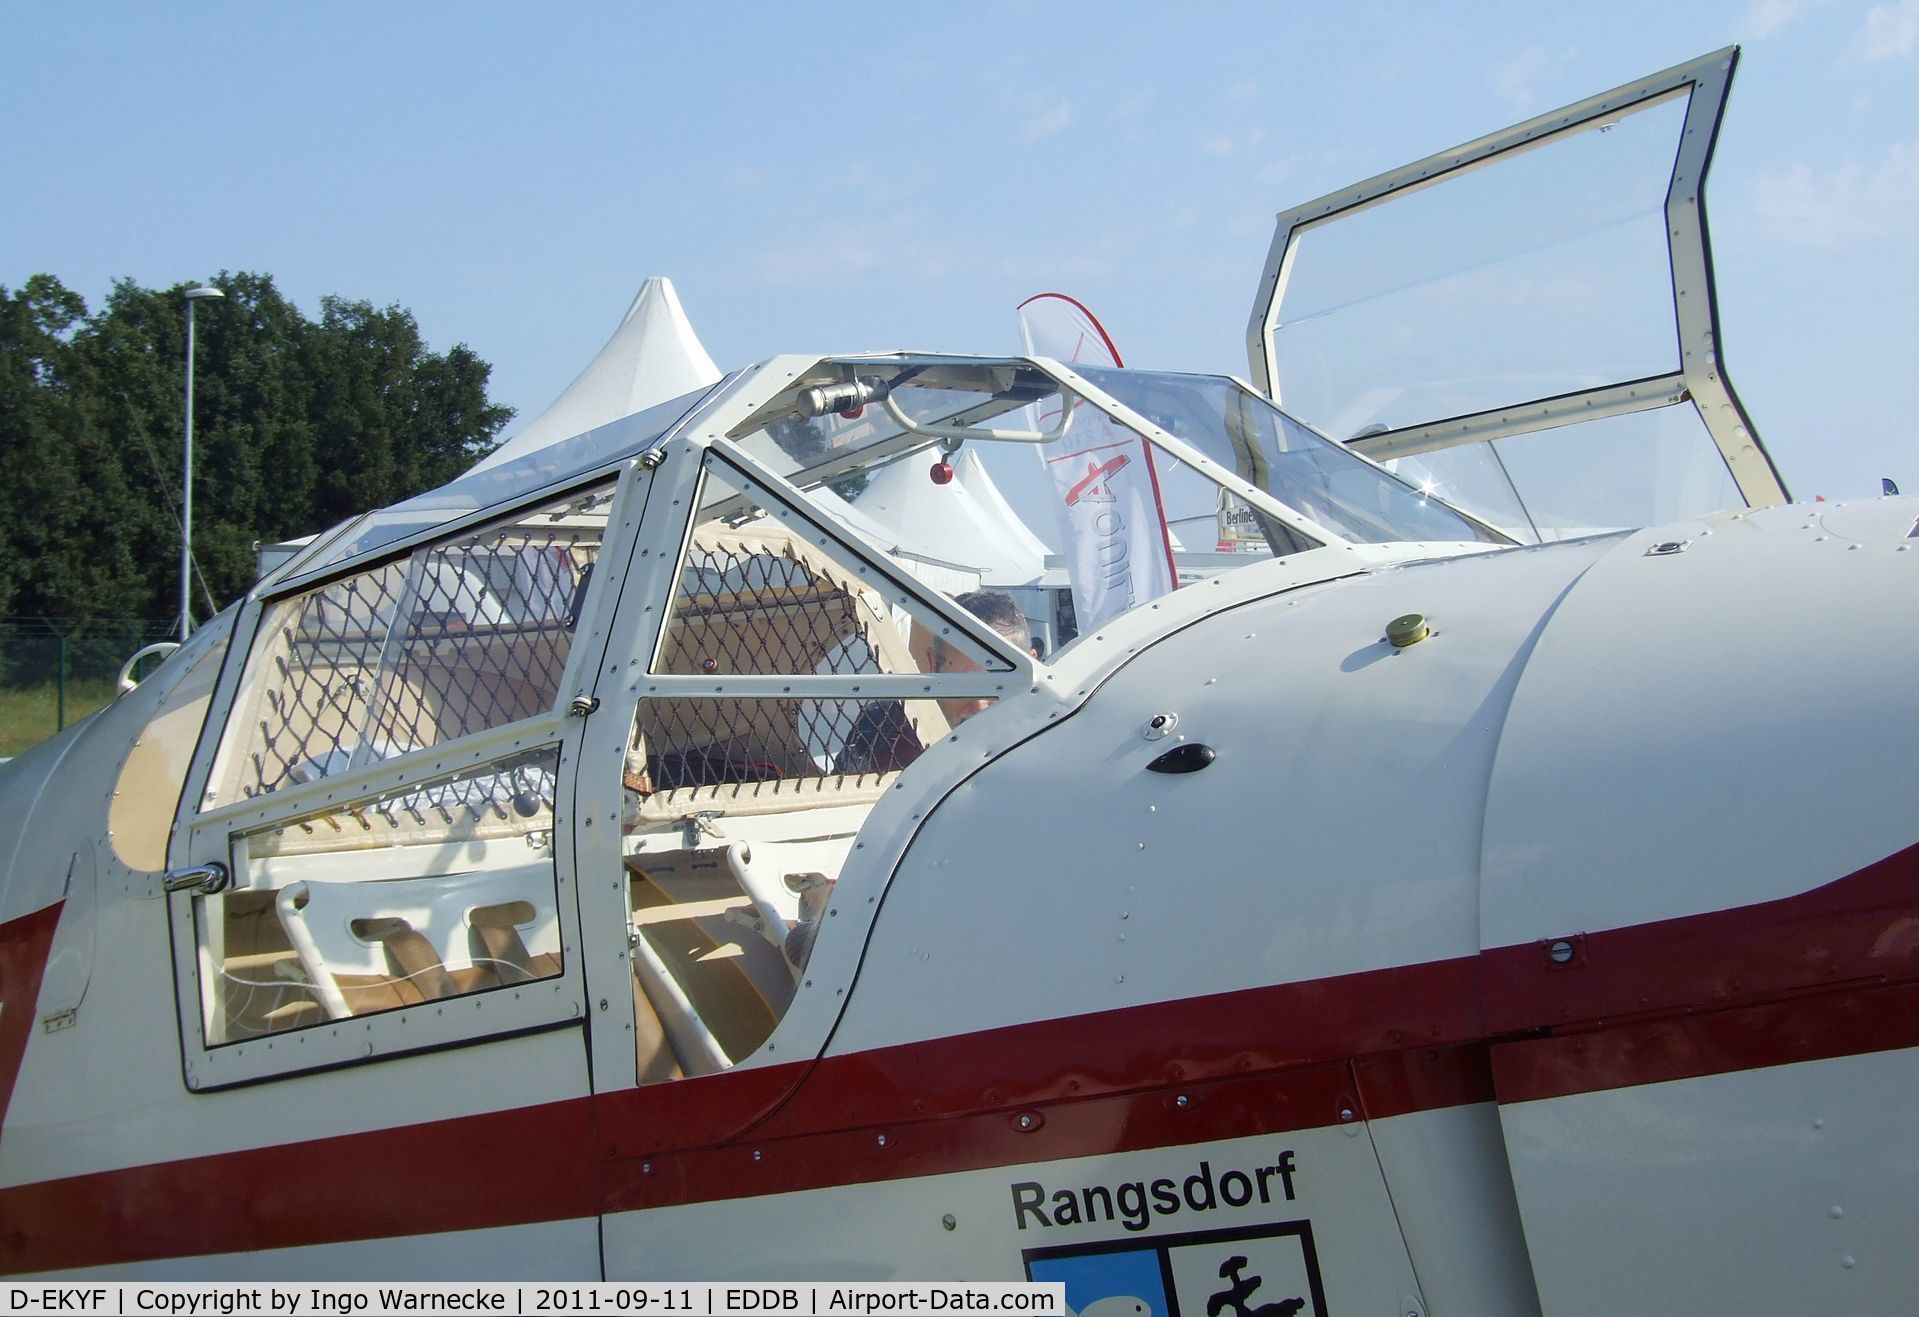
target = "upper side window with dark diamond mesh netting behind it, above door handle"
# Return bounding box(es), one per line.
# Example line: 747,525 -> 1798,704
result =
228,486 -> 612,799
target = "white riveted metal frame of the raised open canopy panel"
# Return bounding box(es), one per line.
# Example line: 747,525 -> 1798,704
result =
1245,46 -> 1787,507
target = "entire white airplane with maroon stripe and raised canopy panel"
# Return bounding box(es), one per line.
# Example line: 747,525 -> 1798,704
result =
0,50 -> 1919,1317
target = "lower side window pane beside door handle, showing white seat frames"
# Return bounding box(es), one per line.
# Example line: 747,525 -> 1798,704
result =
196,747 -> 564,1046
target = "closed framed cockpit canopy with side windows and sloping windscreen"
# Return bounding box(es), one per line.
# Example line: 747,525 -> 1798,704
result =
190,345 -> 1503,1089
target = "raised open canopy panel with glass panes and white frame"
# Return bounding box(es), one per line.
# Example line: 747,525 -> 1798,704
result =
1247,48 -> 1785,539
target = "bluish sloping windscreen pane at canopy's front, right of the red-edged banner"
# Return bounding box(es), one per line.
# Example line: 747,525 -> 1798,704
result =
1080,367 -> 1503,547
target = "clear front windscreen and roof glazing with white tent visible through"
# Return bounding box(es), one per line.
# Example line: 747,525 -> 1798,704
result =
729,355 -> 1508,651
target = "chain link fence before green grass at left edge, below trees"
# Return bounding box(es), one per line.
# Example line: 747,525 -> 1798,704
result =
0,618 -> 178,758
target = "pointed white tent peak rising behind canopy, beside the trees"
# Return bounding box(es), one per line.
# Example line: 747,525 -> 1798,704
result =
472,276 -> 720,470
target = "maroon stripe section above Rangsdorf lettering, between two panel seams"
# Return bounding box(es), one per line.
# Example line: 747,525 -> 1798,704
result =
606,960 -> 1493,1211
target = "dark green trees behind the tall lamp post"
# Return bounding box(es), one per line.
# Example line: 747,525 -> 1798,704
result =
0,273 -> 512,645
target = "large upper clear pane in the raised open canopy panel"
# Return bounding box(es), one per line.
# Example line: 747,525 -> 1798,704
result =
1272,92 -> 1687,440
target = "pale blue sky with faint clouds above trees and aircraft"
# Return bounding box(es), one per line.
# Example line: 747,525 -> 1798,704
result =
0,0 -> 1919,497
